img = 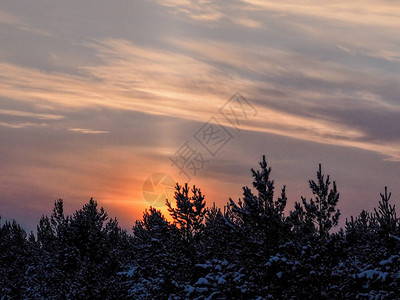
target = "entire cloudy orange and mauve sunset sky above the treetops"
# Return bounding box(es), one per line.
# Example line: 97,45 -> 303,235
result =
0,0 -> 400,230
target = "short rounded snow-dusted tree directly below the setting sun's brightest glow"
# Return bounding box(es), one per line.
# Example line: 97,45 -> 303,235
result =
121,207 -> 190,299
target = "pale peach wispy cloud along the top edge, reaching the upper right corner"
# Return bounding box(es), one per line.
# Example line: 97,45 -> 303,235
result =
156,0 -> 400,66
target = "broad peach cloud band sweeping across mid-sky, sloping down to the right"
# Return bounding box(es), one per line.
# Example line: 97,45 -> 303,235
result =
0,33 -> 400,160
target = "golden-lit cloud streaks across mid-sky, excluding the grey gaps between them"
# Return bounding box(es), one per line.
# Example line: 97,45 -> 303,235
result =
0,34 -> 400,160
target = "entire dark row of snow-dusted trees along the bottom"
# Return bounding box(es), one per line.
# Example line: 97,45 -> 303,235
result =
0,157 -> 400,299
